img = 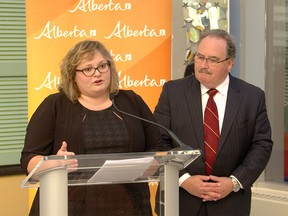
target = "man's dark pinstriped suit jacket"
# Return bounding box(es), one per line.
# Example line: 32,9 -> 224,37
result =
154,75 -> 273,215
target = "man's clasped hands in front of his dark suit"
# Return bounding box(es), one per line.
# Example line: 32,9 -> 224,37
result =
180,175 -> 233,202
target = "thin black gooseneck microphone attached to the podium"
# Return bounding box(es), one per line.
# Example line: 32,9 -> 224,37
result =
109,93 -> 193,151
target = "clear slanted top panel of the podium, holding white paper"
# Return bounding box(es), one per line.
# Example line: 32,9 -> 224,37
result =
21,150 -> 200,187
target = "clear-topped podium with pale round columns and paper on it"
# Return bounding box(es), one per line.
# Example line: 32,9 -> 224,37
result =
21,150 -> 201,216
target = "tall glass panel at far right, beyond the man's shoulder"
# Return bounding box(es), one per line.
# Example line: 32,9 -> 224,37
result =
264,0 -> 288,185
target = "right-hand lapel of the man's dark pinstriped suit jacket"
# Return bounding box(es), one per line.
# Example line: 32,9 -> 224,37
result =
218,76 -> 242,151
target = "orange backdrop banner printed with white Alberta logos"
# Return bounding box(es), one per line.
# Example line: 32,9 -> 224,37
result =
26,0 -> 172,211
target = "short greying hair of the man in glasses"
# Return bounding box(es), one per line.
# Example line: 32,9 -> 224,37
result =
198,29 -> 236,59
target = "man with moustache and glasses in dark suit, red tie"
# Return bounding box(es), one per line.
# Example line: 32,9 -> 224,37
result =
155,29 -> 273,216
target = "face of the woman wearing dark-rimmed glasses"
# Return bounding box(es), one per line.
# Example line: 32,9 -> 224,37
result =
75,52 -> 110,97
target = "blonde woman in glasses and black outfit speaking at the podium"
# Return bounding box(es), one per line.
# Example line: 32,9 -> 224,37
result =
21,40 -> 169,216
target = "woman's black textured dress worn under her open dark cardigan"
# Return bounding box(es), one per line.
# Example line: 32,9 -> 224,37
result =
30,105 -> 152,216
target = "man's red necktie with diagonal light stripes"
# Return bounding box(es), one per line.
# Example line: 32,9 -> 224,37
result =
204,89 -> 220,175
